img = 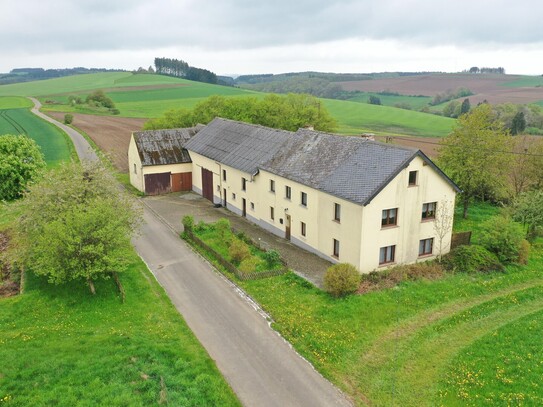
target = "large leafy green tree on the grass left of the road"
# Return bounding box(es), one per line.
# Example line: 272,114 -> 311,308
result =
17,163 -> 139,294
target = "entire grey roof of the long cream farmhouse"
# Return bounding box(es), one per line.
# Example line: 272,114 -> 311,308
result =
186,118 -> 459,205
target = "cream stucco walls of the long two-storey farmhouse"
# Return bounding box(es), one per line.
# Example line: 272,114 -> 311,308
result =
190,152 -> 456,273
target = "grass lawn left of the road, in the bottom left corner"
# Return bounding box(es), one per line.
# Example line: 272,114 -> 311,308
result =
0,207 -> 239,406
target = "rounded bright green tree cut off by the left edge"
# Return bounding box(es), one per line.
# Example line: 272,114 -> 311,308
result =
0,134 -> 45,201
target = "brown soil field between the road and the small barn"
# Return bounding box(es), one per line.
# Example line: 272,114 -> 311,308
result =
48,112 -> 147,172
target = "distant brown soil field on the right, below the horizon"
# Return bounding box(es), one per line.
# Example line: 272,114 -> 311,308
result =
336,74 -> 543,105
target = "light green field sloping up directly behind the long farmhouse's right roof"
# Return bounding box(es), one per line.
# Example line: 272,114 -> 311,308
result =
323,99 -> 456,137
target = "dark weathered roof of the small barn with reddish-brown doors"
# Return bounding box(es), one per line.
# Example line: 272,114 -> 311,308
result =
134,124 -> 204,167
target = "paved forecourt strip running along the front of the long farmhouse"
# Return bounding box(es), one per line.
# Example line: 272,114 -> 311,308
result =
144,192 -> 332,288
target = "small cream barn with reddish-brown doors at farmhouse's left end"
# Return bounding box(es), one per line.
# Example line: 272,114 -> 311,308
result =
128,125 -> 205,195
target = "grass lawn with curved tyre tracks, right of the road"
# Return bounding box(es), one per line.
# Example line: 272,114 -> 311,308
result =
231,205 -> 543,406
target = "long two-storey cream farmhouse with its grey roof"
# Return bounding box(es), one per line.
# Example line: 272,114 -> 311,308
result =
130,118 -> 459,273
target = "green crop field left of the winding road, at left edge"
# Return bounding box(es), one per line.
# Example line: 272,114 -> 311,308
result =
0,98 -> 73,167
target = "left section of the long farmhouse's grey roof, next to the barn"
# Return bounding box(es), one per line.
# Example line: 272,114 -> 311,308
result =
185,118 -> 294,175
